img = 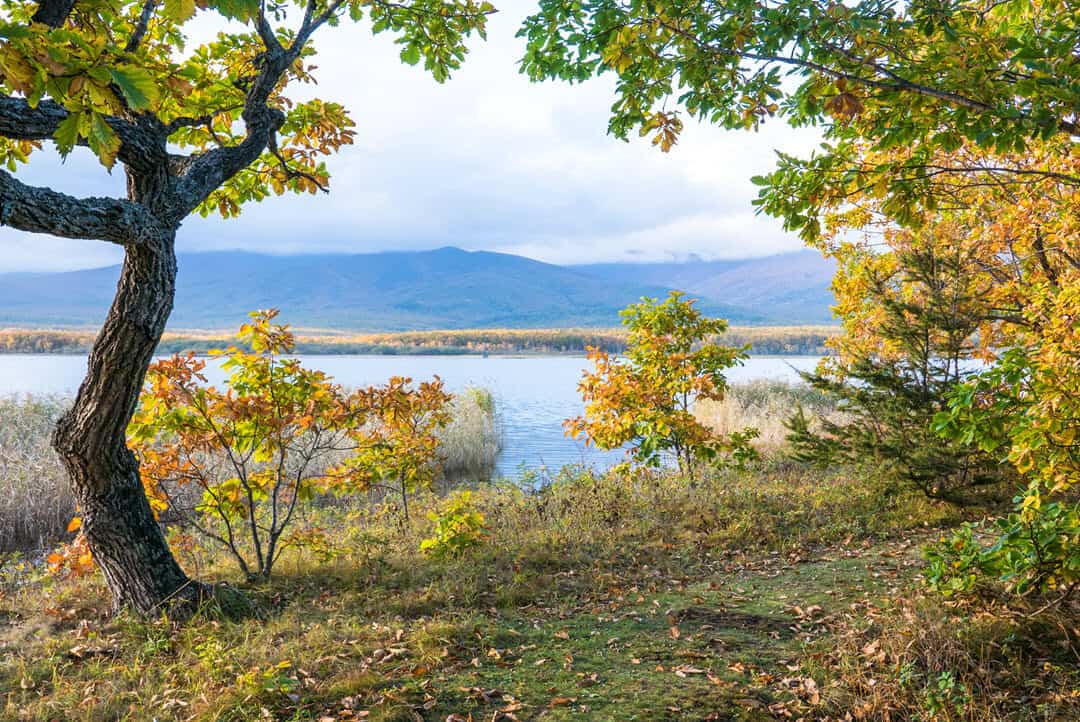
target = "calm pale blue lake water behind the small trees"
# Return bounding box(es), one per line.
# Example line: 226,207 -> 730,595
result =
0,354 -> 818,476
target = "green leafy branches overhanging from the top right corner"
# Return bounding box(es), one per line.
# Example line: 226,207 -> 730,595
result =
519,0 -> 1080,234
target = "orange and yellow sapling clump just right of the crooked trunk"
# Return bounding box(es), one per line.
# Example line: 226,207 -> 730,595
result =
129,311 -> 450,578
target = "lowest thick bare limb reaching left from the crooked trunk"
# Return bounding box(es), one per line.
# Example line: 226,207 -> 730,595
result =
0,171 -> 167,245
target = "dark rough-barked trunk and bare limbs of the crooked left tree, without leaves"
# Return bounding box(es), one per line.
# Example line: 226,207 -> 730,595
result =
0,0 -> 342,614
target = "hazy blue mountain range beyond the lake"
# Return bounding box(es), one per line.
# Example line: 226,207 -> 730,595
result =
0,248 -> 831,330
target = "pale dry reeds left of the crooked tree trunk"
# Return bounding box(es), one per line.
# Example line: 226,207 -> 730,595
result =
0,396 -> 75,553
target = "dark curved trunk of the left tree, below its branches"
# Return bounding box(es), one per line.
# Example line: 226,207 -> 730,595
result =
53,234 -> 202,615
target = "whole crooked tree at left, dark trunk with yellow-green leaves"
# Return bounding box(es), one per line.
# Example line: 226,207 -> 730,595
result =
0,0 -> 494,613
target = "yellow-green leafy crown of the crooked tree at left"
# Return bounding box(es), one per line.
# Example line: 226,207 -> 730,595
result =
0,0 -> 494,230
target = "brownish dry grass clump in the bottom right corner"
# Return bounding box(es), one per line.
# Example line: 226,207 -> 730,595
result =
820,590 -> 1080,722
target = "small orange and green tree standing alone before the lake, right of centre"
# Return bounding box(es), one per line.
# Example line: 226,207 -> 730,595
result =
565,291 -> 756,481
